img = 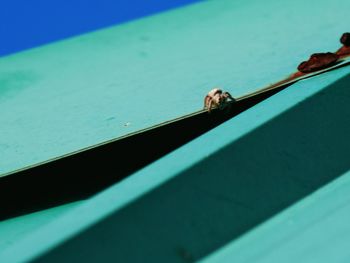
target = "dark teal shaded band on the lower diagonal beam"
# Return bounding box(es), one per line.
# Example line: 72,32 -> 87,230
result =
35,76 -> 350,263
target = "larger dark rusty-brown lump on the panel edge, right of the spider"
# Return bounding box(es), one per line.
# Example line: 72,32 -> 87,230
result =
298,52 -> 339,73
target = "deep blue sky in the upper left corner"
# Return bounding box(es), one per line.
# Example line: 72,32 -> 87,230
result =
0,0 -> 200,56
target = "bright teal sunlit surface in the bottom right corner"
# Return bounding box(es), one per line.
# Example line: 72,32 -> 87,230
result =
201,172 -> 350,263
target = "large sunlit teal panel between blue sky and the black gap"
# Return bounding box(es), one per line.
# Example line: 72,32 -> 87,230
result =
0,0 -> 350,174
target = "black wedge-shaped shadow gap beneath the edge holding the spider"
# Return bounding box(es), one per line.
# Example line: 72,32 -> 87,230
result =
0,78 -> 289,220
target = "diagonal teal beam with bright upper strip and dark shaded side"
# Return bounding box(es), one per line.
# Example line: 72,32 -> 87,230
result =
0,63 -> 350,262
